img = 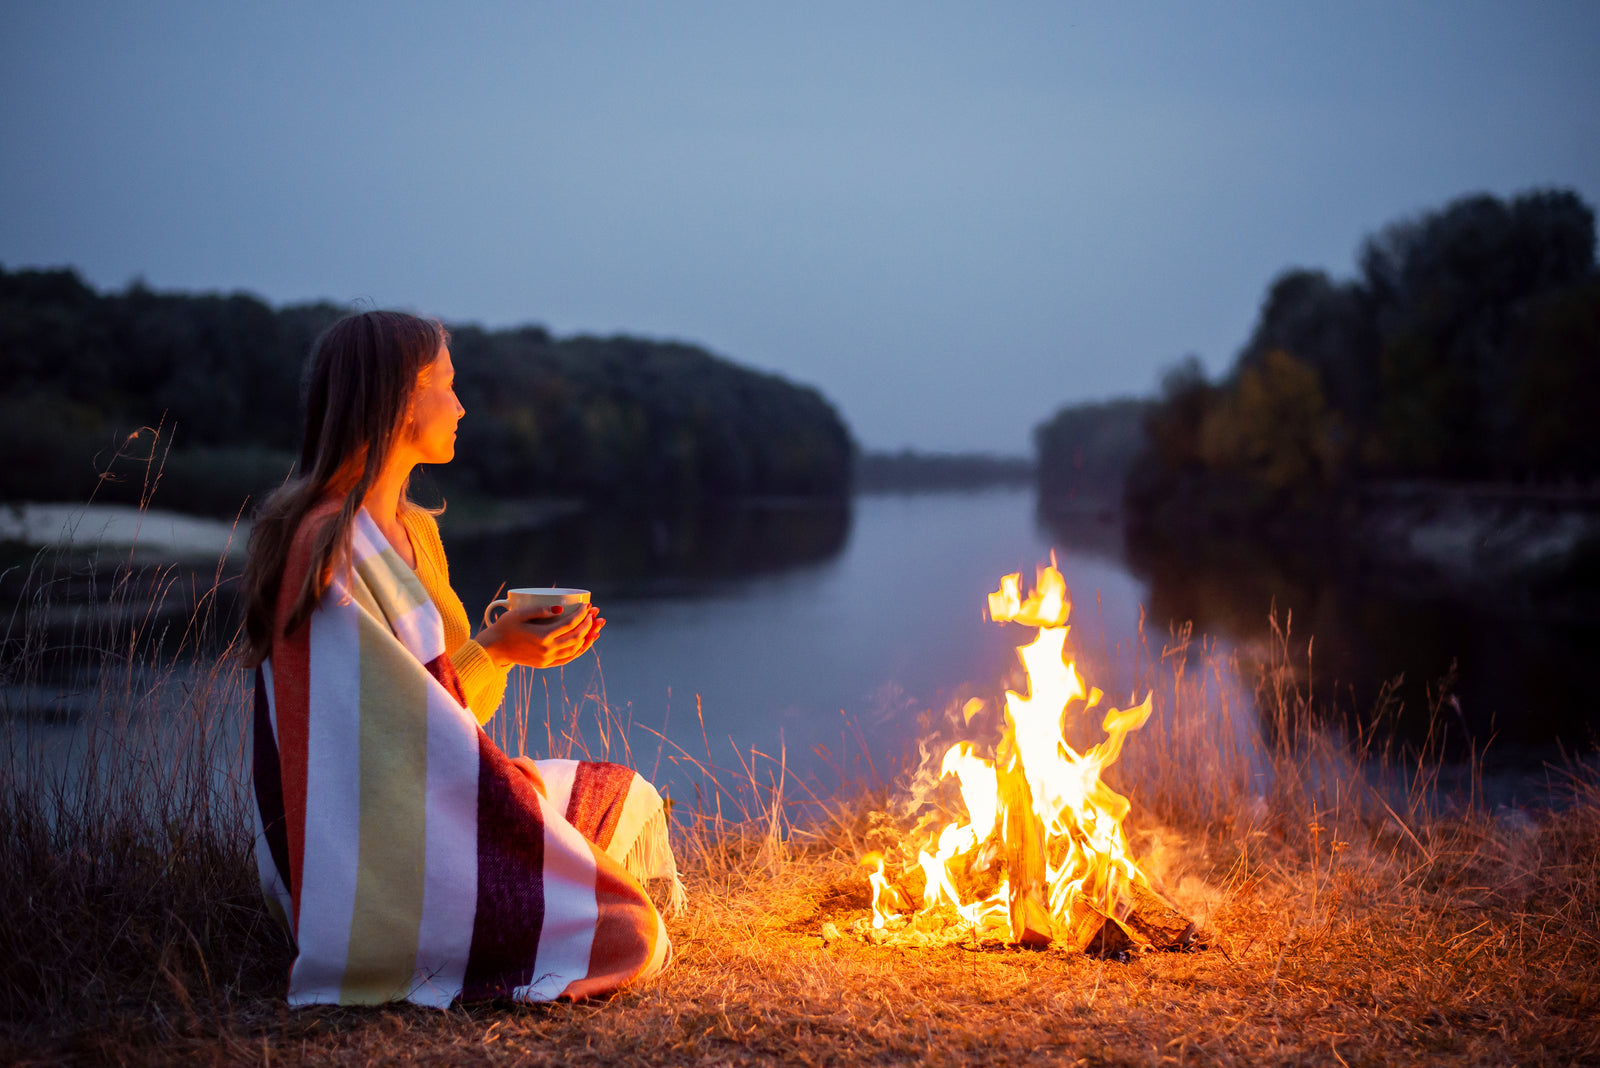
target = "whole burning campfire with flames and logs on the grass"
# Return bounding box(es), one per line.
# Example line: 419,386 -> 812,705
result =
853,563 -> 1195,954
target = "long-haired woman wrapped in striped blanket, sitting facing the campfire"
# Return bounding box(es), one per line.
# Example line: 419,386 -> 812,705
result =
245,312 -> 682,1006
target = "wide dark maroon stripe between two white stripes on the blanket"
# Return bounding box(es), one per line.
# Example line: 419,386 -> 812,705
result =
461,729 -> 544,1001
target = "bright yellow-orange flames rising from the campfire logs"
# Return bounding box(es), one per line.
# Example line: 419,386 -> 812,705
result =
862,563 -> 1150,942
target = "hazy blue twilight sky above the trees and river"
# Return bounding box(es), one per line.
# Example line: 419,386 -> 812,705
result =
0,0 -> 1600,454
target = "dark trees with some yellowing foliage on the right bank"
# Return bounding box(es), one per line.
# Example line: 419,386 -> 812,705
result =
1035,190 -> 1600,529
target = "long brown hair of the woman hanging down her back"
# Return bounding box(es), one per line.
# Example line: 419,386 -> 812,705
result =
245,312 -> 448,667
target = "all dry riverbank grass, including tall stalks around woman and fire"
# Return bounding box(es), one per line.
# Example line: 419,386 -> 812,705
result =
0,511 -> 1600,1065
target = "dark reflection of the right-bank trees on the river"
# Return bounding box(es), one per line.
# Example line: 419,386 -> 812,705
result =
1094,520 -> 1600,755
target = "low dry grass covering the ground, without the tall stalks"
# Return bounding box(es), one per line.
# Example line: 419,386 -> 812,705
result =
5,793 -> 1600,1065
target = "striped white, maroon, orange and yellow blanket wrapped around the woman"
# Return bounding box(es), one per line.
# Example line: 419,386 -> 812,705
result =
253,507 -> 682,1006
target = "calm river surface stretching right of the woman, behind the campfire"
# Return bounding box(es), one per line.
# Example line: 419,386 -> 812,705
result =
443,489 -> 1600,796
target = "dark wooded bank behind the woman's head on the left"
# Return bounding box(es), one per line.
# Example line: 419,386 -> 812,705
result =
0,269 -> 854,515
